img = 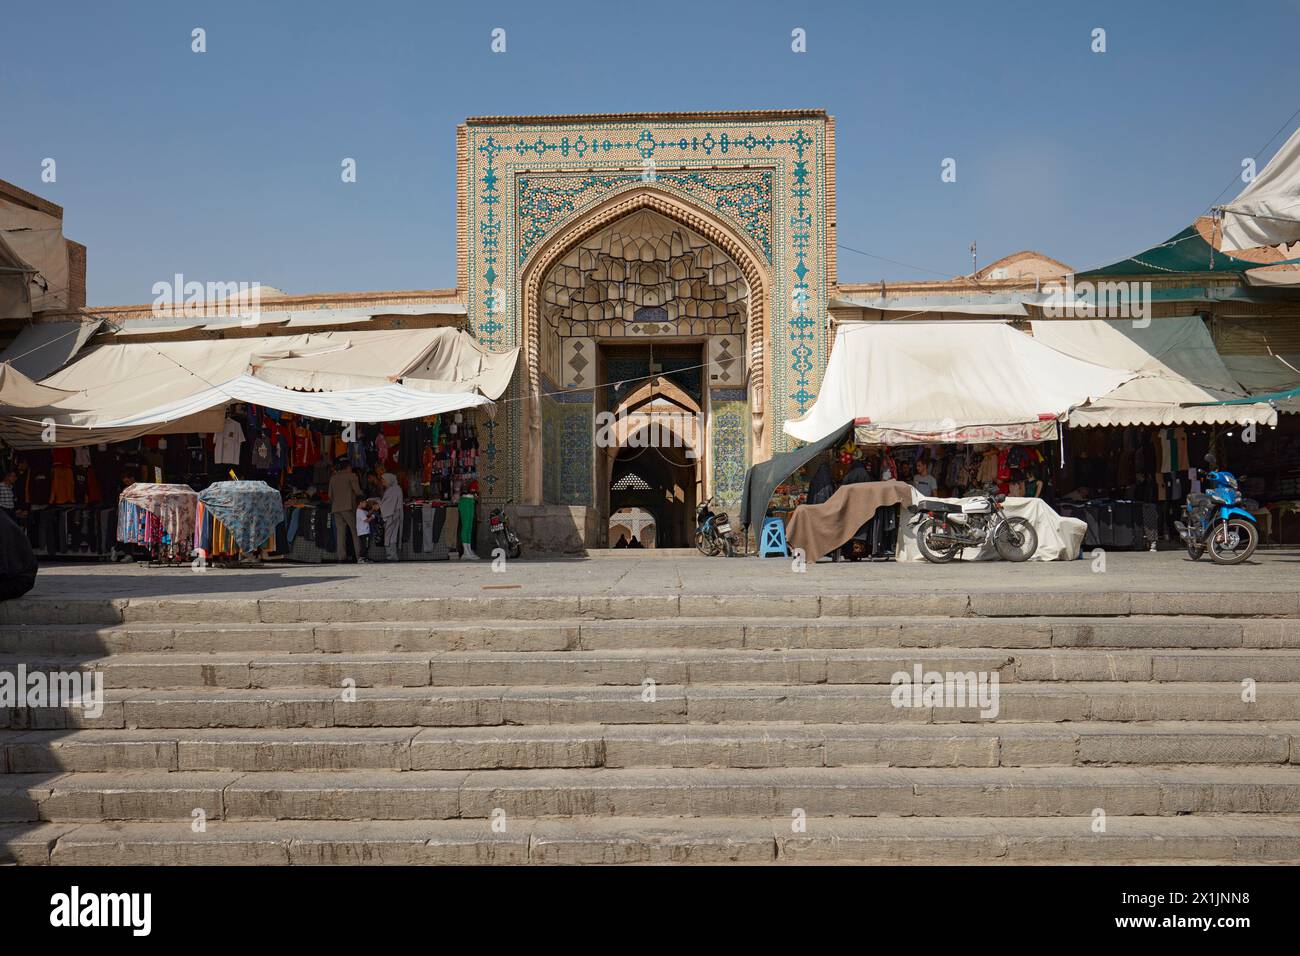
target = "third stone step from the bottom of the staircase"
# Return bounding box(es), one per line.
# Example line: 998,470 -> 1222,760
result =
0,721 -> 1300,774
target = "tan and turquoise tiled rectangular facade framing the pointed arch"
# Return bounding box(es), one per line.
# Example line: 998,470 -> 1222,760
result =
460,114 -> 832,503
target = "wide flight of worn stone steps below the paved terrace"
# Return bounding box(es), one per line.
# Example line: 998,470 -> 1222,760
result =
0,592 -> 1300,865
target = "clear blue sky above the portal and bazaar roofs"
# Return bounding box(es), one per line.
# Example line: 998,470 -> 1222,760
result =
0,0 -> 1300,304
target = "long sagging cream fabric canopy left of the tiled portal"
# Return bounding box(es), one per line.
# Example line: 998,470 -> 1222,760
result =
0,329 -> 517,447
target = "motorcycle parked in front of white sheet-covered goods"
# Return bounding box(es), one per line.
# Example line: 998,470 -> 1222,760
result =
907,485 -> 1039,564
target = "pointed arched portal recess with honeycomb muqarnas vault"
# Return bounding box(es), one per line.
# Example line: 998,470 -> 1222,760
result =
523,187 -> 768,528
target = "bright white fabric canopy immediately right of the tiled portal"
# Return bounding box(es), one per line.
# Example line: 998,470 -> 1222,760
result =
785,321 -> 1134,445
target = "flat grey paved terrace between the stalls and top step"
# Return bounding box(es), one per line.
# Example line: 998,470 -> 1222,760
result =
29,549 -> 1300,600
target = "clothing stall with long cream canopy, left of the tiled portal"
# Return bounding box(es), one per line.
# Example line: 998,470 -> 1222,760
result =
0,328 -> 517,561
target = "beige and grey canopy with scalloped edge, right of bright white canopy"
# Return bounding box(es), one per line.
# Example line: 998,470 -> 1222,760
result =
1031,316 -> 1277,428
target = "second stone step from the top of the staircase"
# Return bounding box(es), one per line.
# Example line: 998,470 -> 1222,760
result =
0,616 -> 1300,658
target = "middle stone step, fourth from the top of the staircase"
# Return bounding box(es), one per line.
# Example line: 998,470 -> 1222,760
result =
0,680 -> 1300,730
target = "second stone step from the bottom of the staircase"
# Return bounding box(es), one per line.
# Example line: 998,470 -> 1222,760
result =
0,766 -> 1300,826
